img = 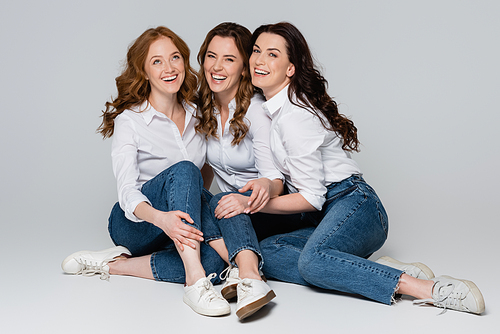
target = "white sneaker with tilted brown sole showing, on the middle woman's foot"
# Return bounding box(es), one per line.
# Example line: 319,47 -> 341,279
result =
236,278 -> 276,320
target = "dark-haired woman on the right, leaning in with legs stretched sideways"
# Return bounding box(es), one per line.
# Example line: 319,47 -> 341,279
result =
250,22 -> 484,313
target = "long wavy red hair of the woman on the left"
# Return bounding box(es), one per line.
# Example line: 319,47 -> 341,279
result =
97,26 -> 198,138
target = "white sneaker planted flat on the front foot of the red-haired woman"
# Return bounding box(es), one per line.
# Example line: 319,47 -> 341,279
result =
183,273 -> 231,316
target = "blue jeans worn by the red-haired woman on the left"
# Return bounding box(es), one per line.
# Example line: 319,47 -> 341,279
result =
108,161 -> 225,283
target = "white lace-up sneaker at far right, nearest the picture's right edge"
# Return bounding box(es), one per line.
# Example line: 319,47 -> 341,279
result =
413,276 -> 484,314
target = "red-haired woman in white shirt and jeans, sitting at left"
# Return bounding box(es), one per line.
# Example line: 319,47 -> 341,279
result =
62,26 -> 230,316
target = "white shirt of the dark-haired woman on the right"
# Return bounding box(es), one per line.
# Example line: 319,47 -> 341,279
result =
263,86 -> 361,210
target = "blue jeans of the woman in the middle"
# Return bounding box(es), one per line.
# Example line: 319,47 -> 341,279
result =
202,191 -> 262,268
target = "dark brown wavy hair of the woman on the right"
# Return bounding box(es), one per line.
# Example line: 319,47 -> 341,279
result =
250,22 -> 360,152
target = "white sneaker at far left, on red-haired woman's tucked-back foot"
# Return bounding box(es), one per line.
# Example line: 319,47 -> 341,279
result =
61,246 -> 132,280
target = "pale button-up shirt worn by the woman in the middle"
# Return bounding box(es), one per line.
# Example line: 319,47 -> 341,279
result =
207,94 -> 283,191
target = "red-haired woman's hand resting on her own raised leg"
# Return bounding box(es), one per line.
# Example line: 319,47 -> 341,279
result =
154,211 -> 203,251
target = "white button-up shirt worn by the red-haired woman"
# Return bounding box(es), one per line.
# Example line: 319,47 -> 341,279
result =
111,102 -> 206,222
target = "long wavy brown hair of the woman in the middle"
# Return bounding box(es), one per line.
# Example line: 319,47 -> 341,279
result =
196,22 -> 254,145
